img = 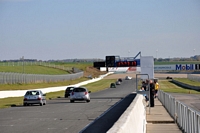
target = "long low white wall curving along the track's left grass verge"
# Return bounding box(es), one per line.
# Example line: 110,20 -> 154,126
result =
0,72 -> 112,98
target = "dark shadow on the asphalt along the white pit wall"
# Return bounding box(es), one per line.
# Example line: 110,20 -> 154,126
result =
80,94 -> 136,133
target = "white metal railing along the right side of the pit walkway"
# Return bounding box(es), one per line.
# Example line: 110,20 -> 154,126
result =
158,90 -> 200,133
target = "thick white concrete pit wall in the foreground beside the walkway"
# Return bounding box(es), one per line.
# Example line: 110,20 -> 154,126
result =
107,94 -> 146,133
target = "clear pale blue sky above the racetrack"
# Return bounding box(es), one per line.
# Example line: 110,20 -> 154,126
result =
0,0 -> 200,60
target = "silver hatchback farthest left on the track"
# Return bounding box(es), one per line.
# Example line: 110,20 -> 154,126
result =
23,90 -> 47,106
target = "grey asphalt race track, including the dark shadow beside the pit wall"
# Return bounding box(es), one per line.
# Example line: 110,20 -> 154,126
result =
0,79 -> 136,133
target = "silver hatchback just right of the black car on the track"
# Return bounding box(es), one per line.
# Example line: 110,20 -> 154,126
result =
70,87 -> 91,103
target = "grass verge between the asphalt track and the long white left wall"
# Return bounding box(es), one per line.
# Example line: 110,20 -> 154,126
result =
0,79 -> 116,108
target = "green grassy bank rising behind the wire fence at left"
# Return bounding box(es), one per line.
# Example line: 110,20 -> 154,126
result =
0,65 -> 69,75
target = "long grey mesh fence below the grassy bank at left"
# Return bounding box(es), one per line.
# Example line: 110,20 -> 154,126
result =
0,72 -> 83,84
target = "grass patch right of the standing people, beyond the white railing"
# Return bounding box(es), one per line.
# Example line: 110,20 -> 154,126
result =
159,80 -> 200,94
